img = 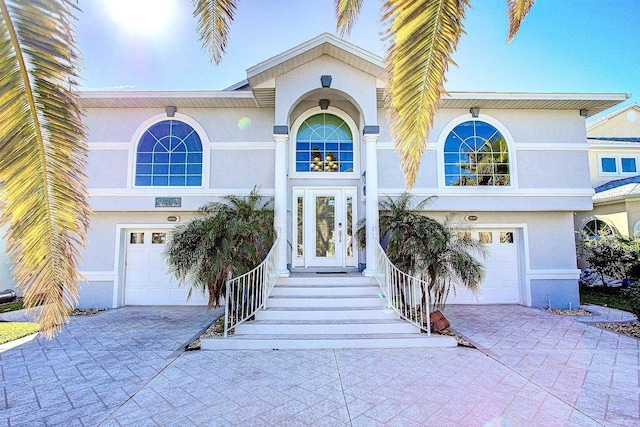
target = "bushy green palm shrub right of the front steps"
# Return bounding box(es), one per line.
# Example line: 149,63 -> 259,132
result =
358,193 -> 485,311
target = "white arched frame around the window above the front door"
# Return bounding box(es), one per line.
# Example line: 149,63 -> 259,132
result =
289,106 -> 361,180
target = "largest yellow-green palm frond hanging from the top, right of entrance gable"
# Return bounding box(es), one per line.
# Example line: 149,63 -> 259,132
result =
383,0 -> 469,188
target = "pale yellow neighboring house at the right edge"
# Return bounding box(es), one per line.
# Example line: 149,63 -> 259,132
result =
575,104 -> 640,241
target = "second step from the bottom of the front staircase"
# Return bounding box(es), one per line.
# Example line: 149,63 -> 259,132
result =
235,319 -> 419,336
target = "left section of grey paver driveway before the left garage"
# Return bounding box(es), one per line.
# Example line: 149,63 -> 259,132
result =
0,307 -> 214,427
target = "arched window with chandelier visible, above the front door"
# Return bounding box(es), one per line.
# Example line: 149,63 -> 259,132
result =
296,113 -> 353,172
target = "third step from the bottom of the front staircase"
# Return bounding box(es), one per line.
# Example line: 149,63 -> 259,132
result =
255,306 -> 400,320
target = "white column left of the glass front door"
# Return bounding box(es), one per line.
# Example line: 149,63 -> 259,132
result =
273,131 -> 289,277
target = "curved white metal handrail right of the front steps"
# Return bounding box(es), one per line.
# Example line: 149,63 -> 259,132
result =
375,242 -> 431,335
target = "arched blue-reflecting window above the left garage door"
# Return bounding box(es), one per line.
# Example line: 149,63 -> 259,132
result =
135,119 -> 202,187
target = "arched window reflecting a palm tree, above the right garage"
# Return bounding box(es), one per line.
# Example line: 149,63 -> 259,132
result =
444,120 -> 511,186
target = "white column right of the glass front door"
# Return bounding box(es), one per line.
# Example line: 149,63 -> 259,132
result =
363,130 -> 380,276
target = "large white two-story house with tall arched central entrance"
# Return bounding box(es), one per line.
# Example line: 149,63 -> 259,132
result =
0,34 -> 626,308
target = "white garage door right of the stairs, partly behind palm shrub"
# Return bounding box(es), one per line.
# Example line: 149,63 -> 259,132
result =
447,229 -> 520,304
